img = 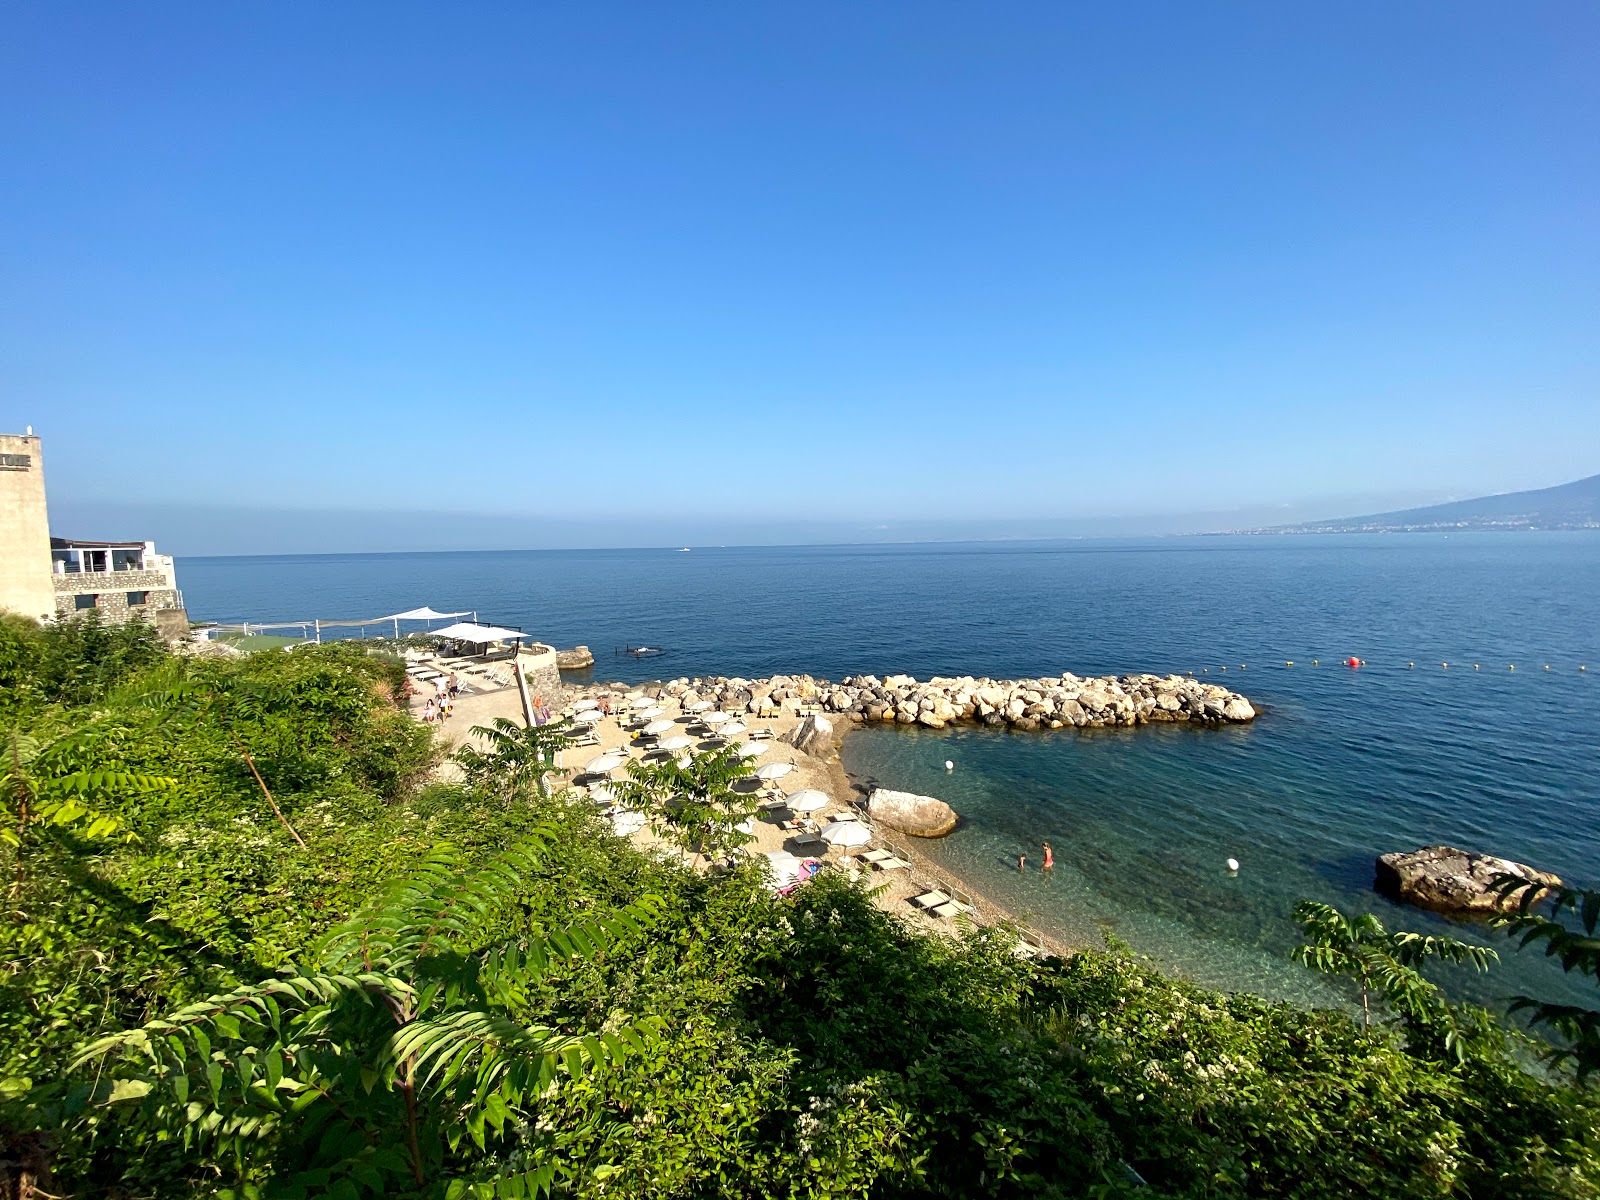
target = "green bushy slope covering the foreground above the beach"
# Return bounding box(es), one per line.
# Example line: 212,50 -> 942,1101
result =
0,622 -> 1600,1197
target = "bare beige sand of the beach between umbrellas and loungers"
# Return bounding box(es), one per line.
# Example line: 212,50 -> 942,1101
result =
411,683 -> 1072,954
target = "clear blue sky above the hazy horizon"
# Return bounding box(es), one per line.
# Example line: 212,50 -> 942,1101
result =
0,0 -> 1600,549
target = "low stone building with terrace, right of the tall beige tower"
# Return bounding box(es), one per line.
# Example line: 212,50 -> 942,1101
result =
50,538 -> 189,638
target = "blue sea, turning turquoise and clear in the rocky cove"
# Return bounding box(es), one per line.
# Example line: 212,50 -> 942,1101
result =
178,531 -> 1600,1005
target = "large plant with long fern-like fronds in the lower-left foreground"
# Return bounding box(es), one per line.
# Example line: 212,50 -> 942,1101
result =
75,832 -> 659,1197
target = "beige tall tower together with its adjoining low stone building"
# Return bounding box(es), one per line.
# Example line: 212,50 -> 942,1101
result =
0,429 -> 189,638
